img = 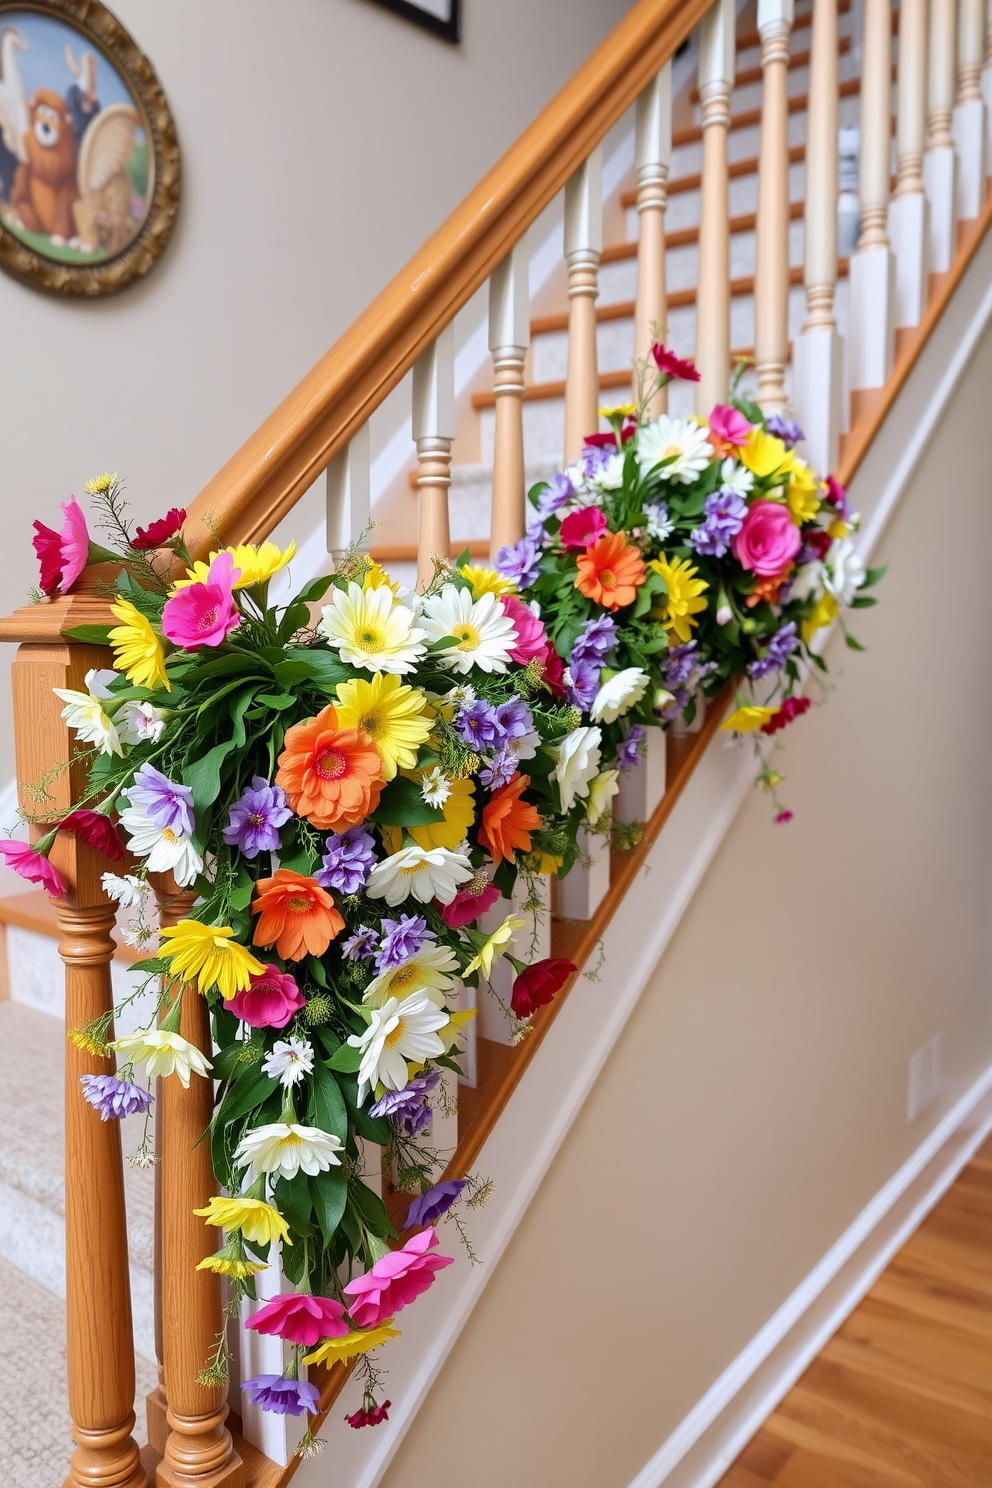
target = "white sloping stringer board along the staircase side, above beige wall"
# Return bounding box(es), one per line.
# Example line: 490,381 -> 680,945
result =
296,212 -> 992,1488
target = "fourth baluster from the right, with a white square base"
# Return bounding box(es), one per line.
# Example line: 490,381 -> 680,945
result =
848,0 -> 895,401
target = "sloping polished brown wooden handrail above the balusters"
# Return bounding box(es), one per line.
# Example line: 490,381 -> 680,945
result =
178,0 -> 709,557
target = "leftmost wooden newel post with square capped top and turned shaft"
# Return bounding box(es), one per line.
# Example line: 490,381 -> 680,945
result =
0,576 -> 147,1488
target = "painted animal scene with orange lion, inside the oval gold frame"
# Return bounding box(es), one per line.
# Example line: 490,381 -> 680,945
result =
0,9 -> 152,262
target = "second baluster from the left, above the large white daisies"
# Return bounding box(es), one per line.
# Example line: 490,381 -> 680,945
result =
413,323 -> 455,585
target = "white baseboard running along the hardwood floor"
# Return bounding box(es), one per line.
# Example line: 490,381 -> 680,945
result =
631,1065 -> 992,1488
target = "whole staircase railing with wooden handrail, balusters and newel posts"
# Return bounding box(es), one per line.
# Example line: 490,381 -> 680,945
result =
0,0 -> 992,1488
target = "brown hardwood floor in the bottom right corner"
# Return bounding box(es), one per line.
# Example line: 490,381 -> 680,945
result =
718,1138 -> 992,1488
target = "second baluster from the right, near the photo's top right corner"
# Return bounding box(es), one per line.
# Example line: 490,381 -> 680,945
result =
924,0 -> 958,274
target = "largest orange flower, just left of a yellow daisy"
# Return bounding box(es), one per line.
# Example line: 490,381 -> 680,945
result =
275,704 -> 382,832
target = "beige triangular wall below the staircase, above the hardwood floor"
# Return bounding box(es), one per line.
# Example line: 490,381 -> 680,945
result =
376,319 -> 992,1488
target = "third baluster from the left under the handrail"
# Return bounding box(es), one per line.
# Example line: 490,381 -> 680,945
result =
489,243 -> 531,558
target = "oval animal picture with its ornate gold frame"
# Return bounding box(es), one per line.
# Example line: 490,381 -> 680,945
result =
0,0 -> 180,295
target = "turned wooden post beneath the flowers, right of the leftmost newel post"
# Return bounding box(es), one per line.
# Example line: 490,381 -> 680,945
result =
155,878 -> 244,1488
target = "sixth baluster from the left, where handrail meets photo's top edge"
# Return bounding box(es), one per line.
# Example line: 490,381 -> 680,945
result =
696,0 -> 735,415
